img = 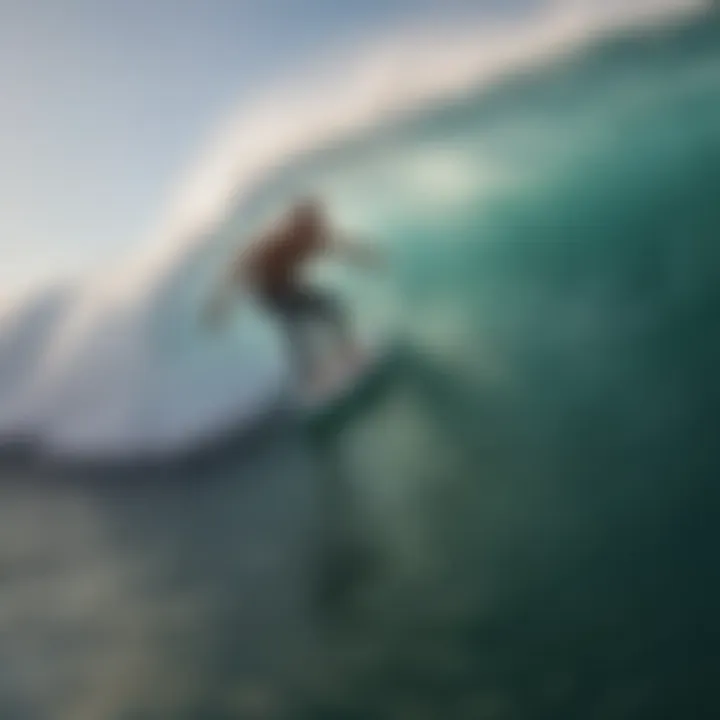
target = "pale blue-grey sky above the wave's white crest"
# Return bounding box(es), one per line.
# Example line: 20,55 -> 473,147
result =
0,0 -> 528,294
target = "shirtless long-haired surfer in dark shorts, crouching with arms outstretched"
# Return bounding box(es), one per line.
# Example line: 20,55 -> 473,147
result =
206,198 -> 377,382
